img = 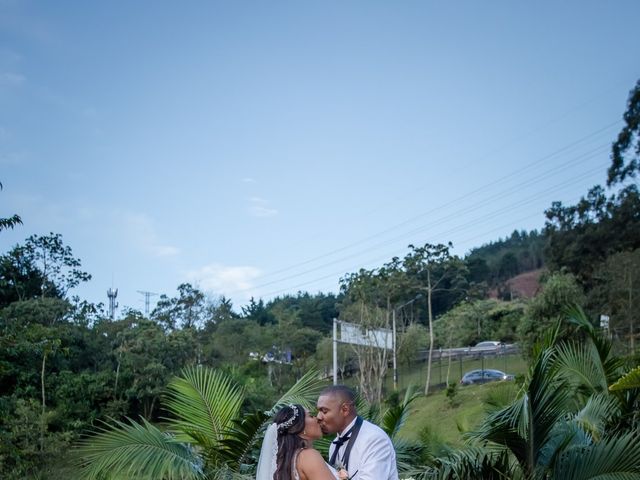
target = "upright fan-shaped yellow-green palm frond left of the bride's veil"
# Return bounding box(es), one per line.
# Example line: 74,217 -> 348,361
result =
166,367 -> 244,449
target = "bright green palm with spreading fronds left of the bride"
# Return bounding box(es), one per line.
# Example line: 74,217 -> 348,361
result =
78,367 -> 324,480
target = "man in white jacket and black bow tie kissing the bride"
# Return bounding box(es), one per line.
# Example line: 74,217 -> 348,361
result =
317,385 -> 398,480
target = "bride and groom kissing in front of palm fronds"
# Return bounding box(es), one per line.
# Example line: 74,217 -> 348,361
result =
256,385 -> 398,480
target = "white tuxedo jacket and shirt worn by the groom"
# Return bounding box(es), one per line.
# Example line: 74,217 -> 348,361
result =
329,419 -> 398,480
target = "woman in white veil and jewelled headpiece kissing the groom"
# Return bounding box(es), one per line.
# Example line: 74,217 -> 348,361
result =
256,404 -> 349,480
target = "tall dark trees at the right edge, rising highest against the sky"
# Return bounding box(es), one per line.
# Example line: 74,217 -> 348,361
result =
544,82 -> 640,353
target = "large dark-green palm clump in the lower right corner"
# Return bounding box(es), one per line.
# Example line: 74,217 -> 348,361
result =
410,308 -> 640,480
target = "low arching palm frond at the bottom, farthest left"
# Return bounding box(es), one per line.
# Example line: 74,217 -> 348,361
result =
77,419 -> 204,480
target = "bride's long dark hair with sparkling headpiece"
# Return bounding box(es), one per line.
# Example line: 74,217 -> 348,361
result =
273,404 -> 308,480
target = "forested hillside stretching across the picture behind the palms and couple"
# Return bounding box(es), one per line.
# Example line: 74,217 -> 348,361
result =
0,79 -> 640,478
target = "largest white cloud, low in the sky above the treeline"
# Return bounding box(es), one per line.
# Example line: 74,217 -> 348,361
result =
186,263 -> 261,295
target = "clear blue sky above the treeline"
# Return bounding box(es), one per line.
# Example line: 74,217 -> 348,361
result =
0,0 -> 640,310
